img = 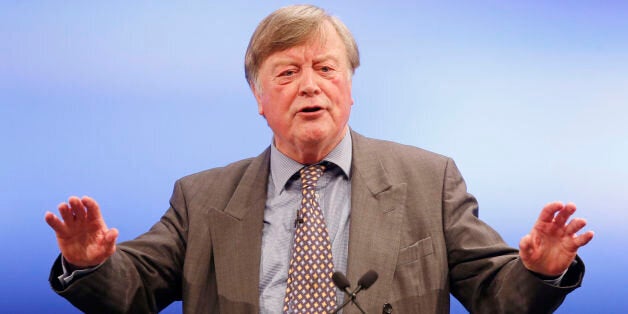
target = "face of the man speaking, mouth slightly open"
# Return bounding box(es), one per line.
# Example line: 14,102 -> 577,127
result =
253,22 -> 353,164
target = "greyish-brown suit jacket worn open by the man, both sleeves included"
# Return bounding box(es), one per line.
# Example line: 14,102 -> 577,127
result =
50,132 -> 584,314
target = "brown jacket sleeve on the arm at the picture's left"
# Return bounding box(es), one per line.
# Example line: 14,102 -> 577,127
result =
49,181 -> 188,313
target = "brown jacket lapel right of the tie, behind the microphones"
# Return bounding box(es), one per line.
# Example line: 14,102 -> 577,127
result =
344,132 -> 406,314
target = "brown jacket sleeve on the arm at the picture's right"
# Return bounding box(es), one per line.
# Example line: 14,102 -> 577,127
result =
442,160 -> 584,313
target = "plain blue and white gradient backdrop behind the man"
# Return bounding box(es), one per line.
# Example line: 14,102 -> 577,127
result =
0,0 -> 628,313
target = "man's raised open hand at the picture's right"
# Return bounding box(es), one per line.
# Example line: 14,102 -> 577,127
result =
519,202 -> 593,276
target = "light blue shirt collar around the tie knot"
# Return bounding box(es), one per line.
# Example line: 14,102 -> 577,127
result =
270,130 -> 352,192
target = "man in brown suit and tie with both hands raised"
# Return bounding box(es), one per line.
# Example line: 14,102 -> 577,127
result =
46,5 -> 593,313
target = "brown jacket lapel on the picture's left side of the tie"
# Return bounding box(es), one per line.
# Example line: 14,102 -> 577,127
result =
210,149 -> 270,313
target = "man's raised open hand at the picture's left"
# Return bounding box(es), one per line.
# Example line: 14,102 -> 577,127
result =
45,196 -> 118,268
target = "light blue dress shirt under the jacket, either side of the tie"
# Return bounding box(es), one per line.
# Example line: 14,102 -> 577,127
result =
259,132 -> 352,314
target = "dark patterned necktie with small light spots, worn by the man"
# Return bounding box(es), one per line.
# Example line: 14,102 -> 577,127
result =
283,164 -> 336,314
